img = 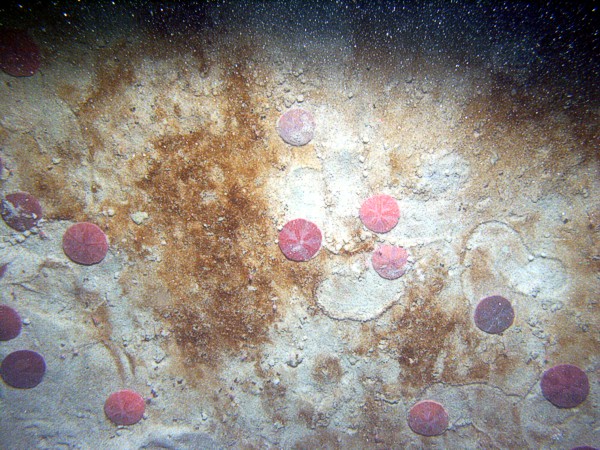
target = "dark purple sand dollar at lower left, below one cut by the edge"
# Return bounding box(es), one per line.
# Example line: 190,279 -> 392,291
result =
0,350 -> 46,389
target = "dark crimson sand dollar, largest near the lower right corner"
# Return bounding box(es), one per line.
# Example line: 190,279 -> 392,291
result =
540,364 -> 590,408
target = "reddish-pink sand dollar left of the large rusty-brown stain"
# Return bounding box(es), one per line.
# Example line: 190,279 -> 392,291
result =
63,222 -> 108,265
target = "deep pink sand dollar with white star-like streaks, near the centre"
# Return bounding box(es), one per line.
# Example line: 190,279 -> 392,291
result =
279,219 -> 323,261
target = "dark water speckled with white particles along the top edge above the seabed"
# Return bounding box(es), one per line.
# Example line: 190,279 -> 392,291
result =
0,0 -> 600,99
